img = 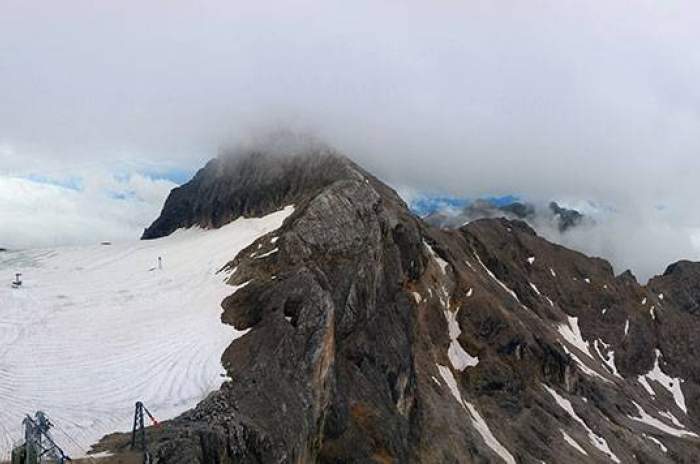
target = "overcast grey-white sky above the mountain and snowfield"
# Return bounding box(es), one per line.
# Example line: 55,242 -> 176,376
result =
0,0 -> 700,277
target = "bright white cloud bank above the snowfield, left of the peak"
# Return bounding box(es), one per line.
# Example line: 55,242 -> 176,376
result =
0,174 -> 175,249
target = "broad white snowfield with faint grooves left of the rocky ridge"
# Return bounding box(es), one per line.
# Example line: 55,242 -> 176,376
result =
0,206 -> 293,462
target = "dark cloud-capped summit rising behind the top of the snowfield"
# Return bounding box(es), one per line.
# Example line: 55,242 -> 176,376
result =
142,146 -> 380,239
